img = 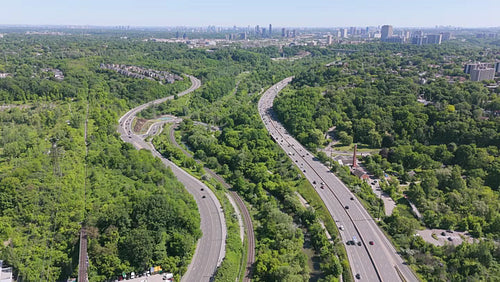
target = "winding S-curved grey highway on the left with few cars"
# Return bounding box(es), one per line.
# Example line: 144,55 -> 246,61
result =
118,76 -> 227,282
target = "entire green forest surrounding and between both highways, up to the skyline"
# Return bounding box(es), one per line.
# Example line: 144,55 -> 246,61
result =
0,28 -> 500,281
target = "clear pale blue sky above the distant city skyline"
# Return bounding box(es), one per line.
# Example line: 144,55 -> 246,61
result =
0,0 -> 500,27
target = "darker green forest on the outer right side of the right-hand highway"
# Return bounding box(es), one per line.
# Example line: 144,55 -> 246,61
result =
274,43 -> 500,281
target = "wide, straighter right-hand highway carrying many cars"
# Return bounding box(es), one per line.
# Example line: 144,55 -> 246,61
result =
258,77 -> 418,282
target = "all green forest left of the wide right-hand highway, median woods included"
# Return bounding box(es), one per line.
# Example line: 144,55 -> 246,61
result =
0,33 -> 342,281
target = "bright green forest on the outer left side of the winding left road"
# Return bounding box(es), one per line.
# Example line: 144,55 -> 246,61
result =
0,35 -> 207,281
